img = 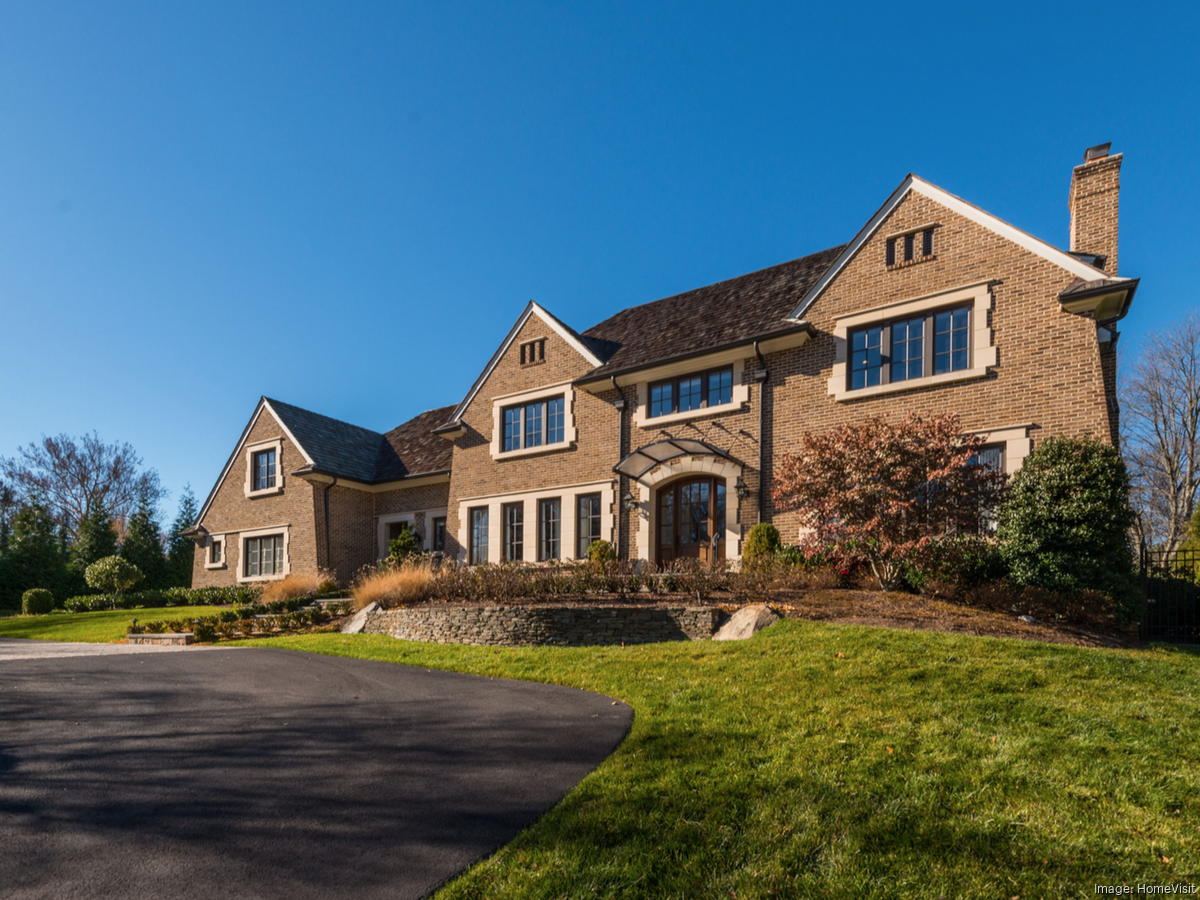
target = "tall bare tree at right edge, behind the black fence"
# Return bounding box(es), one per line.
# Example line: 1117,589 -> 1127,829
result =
1121,312 -> 1200,553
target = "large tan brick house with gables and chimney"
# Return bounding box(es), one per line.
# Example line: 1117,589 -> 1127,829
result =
184,145 -> 1138,586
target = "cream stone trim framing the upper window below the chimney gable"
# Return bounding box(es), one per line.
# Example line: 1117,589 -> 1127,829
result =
830,281 -> 998,400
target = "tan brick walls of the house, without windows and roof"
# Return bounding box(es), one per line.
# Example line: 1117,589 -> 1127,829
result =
193,156 -> 1121,573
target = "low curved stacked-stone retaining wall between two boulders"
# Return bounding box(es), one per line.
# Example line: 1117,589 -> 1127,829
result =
362,606 -> 726,647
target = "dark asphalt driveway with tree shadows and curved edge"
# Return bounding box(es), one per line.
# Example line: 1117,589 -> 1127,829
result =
0,648 -> 632,900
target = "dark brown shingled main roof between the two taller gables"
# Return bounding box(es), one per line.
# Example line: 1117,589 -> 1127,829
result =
578,245 -> 846,382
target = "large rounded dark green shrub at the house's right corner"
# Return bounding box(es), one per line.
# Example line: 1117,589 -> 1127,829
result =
1000,438 -> 1139,614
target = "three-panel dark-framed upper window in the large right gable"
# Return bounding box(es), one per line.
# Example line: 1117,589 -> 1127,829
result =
848,306 -> 971,390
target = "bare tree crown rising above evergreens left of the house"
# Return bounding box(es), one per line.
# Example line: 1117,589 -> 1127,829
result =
0,432 -> 167,539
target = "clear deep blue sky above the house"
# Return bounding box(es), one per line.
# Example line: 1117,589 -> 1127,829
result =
0,0 -> 1200,517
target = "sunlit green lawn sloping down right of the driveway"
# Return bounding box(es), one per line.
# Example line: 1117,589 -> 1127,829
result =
248,628 -> 1200,900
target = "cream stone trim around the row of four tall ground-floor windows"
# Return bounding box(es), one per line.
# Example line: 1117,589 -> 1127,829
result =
458,481 -> 617,563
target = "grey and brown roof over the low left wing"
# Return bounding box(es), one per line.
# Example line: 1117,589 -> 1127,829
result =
265,397 -> 454,485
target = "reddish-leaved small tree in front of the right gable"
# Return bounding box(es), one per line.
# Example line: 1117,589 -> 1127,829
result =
773,415 -> 1004,590
